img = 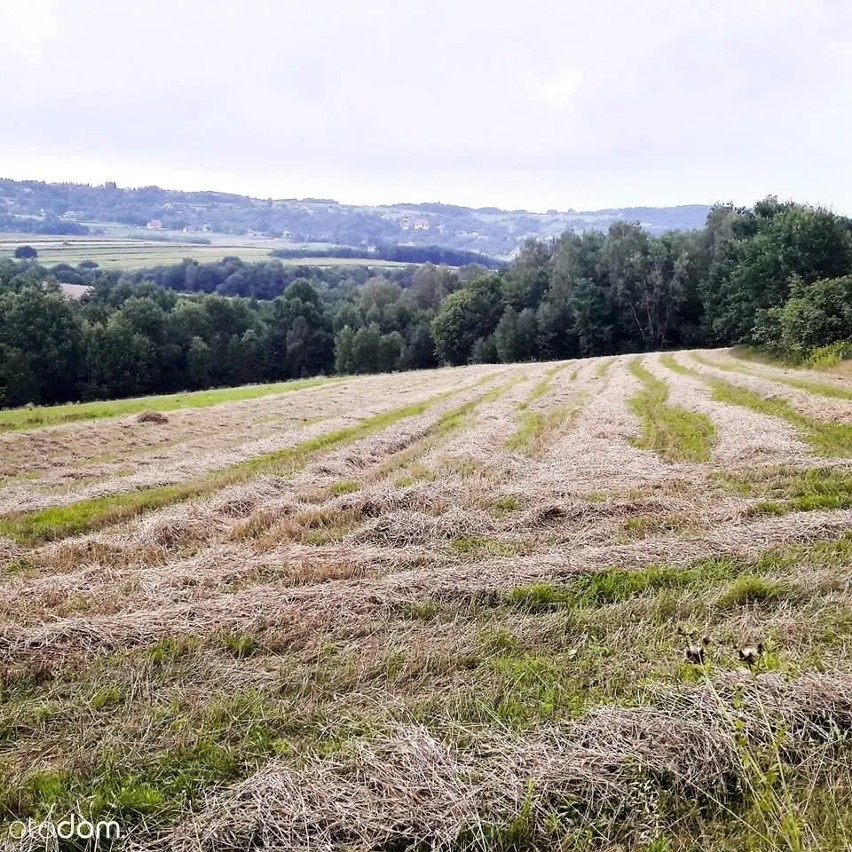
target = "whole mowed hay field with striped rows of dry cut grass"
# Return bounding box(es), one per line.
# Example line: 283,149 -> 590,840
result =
0,350 -> 852,852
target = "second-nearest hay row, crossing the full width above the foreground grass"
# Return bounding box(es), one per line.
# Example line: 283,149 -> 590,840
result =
0,510 -> 852,661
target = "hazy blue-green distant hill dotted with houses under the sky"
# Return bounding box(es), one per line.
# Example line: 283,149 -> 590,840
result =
0,179 -> 710,257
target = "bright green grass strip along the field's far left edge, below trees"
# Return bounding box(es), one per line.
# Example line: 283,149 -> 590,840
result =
0,378 -> 343,432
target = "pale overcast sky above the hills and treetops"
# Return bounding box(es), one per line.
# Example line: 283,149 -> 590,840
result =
0,0 -> 852,213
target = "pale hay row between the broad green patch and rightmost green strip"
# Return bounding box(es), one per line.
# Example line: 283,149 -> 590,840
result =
646,356 -> 812,468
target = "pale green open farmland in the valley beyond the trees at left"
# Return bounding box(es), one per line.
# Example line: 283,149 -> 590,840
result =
0,233 -> 405,269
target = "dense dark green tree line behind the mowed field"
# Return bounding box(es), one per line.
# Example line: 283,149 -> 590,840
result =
0,198 -> 852,406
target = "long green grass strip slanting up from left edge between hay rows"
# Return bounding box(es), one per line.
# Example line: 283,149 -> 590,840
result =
0,391 -> 458,546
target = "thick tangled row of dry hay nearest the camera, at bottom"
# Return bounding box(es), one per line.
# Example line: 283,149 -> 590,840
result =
153,674 -> 852,852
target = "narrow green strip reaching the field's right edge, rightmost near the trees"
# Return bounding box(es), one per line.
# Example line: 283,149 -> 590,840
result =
666,354 -> 852,458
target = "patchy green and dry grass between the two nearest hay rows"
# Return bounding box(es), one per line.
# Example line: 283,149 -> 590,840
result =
0,536 -> 852,852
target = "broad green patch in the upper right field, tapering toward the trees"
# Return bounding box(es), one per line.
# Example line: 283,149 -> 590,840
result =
630,361 -> 716,462
